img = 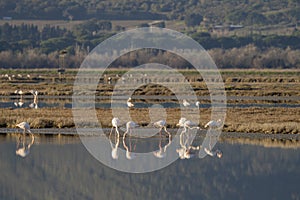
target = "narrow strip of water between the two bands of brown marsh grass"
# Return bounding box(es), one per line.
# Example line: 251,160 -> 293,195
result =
0,95 -> 300,109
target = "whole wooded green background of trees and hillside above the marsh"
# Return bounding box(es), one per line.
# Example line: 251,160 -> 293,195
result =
0,0 -> 300,68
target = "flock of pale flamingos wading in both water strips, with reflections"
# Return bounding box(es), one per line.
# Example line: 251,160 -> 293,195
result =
15,90 -> 222,159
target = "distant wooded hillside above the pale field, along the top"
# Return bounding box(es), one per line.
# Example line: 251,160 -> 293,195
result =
0,0 -> 300,25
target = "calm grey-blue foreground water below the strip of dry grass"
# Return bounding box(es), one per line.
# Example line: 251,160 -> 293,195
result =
0,132 -> 300,199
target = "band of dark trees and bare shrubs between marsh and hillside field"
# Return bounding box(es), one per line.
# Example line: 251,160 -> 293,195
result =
0,19 -> 300,68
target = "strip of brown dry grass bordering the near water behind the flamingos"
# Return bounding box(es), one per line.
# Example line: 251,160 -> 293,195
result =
0,108 -> 300,134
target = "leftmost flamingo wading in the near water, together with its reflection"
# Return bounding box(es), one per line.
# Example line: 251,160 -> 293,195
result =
16,122 -> 34,158
